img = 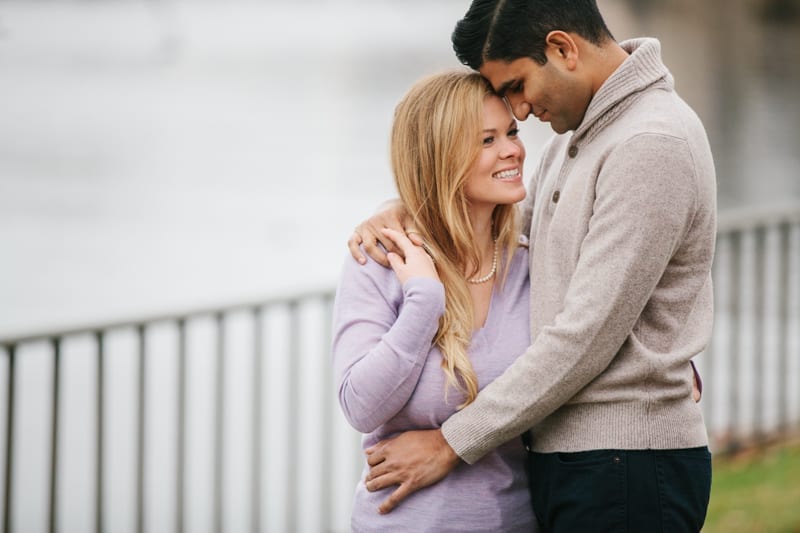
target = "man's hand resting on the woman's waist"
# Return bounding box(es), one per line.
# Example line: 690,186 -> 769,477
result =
365,429 -> 460,514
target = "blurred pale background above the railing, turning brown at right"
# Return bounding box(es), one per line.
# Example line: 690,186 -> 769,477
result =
0,0 -> 800,334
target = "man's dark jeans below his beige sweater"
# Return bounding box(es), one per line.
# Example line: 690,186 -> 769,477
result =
528,446 -> 711,533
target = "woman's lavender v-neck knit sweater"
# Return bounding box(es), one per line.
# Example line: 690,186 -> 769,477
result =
333,247 -> 536,533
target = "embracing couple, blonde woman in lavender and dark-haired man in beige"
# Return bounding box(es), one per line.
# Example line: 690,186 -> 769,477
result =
333,0 -> 716,532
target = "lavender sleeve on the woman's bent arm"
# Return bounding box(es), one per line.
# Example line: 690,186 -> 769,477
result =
332,255 -> 444,433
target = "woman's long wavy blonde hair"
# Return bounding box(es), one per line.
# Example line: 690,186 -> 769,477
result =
391,70 -> 518,408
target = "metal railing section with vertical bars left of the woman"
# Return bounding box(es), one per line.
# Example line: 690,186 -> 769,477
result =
0,291 -> 360,532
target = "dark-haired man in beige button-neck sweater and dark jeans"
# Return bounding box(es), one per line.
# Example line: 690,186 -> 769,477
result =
349,0 -> 716,532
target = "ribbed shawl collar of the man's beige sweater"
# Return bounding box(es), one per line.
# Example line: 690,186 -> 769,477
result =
573,38 -> 674,141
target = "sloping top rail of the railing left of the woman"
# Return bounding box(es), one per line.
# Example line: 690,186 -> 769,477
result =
0,289 -> 334,347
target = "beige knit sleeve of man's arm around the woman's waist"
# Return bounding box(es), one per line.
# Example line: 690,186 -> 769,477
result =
442,134 -> 713,463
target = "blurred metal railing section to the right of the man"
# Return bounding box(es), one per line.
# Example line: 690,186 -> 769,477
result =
697,204 -> 800,451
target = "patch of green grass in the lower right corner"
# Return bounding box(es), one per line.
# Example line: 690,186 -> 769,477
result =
703,443 -> 800,533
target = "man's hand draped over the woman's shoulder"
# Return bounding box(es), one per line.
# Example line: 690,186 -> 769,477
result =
347,200 -> 412,268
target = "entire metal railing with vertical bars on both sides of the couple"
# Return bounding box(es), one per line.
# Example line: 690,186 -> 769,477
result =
0,205 -> 800,533
